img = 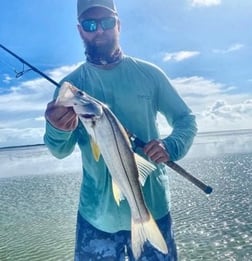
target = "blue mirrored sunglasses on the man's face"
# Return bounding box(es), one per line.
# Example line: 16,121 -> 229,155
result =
80,17 -> 116,32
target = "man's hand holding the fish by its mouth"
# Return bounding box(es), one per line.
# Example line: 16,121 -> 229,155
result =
45,100 -> 78,131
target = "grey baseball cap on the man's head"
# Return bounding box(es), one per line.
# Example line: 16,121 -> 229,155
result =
77,0 -> 117,18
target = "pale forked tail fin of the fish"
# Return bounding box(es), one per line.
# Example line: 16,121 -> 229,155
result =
131,215 -> 168,260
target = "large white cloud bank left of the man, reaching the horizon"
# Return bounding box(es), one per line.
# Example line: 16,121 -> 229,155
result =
0,61 -> 79,147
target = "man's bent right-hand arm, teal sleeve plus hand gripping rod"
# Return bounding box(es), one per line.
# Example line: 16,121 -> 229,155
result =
144,68 -> 197,163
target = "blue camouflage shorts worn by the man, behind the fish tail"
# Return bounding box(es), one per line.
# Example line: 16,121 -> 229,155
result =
74,213 -> 177,261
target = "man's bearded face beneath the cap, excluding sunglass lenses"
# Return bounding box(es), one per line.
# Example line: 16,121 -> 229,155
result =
78,7 -> 120,59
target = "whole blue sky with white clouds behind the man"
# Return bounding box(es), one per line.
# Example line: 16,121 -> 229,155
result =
0,0 -> 252,147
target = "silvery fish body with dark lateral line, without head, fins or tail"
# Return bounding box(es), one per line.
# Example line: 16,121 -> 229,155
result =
94,103 -> 149,222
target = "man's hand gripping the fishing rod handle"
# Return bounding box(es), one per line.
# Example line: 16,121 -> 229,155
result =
143,140 -> 170,163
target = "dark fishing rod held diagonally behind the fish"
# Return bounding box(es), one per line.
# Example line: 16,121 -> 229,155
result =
0,44 -> 213,194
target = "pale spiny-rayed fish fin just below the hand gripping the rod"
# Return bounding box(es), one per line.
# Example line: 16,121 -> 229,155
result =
134,153 -> 157,186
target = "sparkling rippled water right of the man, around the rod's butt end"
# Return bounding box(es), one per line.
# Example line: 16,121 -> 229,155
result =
172,154 -> 252,261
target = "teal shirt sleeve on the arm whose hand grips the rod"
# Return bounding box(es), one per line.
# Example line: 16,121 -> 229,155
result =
157,67 -> 197,161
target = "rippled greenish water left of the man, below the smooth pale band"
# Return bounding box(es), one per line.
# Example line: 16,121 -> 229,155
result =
0,175 -> 79,261
